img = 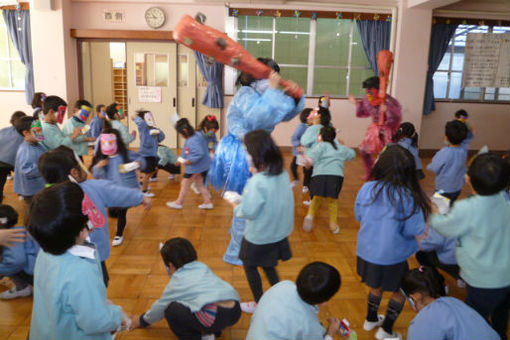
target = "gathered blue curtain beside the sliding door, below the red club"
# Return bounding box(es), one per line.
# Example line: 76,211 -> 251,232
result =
195,51 -> 225,108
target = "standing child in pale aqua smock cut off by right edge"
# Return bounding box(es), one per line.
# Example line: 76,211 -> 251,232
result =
429,153 -> 510,338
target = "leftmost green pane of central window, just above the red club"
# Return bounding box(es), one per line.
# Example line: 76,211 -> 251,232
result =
237,16 -> 273,58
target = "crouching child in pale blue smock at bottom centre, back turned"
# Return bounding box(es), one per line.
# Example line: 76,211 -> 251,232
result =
246,262 -> 341,340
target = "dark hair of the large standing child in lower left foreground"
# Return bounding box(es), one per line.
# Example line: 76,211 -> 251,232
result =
28,181 -> 88,255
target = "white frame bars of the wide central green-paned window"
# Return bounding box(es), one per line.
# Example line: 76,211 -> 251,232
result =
233,15 -> 373,99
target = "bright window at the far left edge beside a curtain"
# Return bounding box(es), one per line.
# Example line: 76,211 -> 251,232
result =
0,10 -> 25,90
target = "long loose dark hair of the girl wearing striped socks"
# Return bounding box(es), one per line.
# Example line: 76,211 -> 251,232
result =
370,144 -> 431,220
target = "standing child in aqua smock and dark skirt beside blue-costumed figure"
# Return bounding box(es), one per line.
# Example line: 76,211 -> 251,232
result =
230,130 -> 294,312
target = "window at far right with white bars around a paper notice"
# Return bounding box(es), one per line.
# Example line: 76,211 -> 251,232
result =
434,25 -> 510,101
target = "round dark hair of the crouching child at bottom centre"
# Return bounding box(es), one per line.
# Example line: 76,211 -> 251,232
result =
296,262 -> 342,305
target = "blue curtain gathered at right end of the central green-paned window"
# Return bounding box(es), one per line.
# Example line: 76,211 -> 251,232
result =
356,20 -> 391,75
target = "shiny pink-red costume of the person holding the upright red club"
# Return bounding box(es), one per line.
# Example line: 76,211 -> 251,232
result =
356,95 -> 402,178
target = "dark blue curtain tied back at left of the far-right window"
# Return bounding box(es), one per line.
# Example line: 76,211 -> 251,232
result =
423,24 -> 457,115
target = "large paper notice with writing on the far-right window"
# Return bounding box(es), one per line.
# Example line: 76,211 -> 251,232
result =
462,33 -> 510,87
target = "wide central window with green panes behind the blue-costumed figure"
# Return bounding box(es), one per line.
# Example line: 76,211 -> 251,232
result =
237,16 -> 374,97
